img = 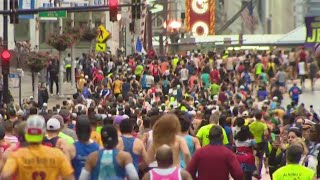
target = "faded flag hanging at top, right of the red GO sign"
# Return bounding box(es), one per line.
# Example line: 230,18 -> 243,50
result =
241,1 -> 258,30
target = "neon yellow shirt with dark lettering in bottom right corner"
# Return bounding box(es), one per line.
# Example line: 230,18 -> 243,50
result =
272,164 -> 315,180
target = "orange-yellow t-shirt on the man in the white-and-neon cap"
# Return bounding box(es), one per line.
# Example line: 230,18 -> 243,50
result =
2,145 -> 73,180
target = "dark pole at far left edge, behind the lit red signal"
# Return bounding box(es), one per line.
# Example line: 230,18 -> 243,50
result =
2,0 -> 10,103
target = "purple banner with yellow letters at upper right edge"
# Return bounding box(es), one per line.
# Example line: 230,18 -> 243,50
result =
304,16 -> 320,48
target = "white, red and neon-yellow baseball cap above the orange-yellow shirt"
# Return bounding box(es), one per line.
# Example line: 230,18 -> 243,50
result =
25,115 -> 46,143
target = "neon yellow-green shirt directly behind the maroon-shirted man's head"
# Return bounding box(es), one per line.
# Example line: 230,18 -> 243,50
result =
197,124 -> 229,146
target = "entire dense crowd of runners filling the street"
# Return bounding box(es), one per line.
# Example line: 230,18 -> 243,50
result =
0,48 -> 320,180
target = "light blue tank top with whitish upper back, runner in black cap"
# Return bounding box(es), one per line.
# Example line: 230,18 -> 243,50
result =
90,149 -> 126,180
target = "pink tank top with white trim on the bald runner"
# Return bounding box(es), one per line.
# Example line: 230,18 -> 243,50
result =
150,167 -> 182,180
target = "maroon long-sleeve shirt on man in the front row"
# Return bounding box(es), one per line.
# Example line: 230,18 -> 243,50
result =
187,145 -> 243,180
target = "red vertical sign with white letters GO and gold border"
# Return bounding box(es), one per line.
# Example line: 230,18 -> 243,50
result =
186,0 -> 216,37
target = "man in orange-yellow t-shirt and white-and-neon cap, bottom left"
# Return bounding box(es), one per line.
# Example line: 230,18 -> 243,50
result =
1,115 -> 74,180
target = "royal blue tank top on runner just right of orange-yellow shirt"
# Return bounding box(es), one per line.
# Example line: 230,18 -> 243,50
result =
71,141 -> 99,179
